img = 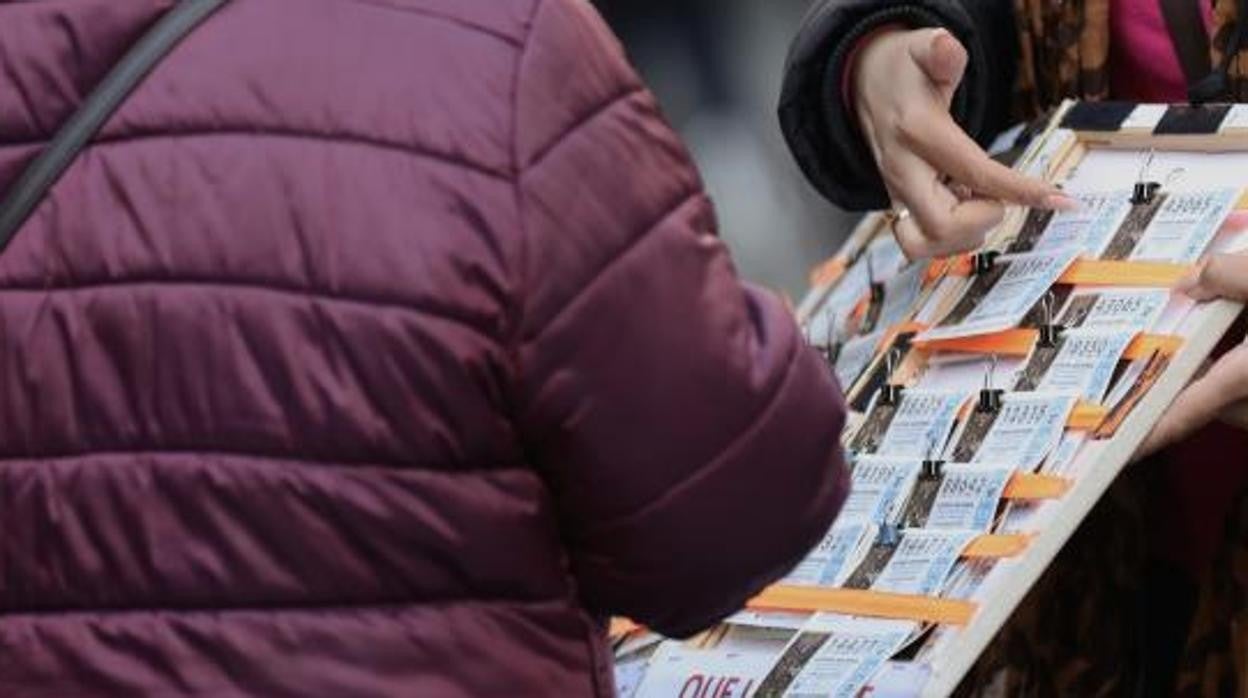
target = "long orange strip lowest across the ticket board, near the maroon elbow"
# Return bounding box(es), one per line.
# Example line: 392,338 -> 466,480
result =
746,584 -> 976,626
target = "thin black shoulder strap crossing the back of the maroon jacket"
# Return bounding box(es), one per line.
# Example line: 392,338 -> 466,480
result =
0,0 -> 230,252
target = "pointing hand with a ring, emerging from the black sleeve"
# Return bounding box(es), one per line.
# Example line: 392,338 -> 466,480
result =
851,27 -> 1073,258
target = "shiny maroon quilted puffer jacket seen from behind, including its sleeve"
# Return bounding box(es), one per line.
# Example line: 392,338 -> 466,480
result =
0,0 -> 845,698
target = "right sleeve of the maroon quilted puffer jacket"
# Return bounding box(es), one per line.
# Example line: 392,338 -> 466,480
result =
517,0 -> 847,636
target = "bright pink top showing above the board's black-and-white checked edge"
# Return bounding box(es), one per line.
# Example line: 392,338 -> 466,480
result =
1109,0 -> 1213,102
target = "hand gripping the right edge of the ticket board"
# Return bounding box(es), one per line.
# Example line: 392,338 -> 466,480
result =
1137,255 -> 1248,458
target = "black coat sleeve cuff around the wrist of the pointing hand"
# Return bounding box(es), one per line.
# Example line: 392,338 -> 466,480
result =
780,0 -> 1018,210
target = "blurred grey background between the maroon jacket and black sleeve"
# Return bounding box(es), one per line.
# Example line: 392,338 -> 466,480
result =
594,0 -> 854,300
